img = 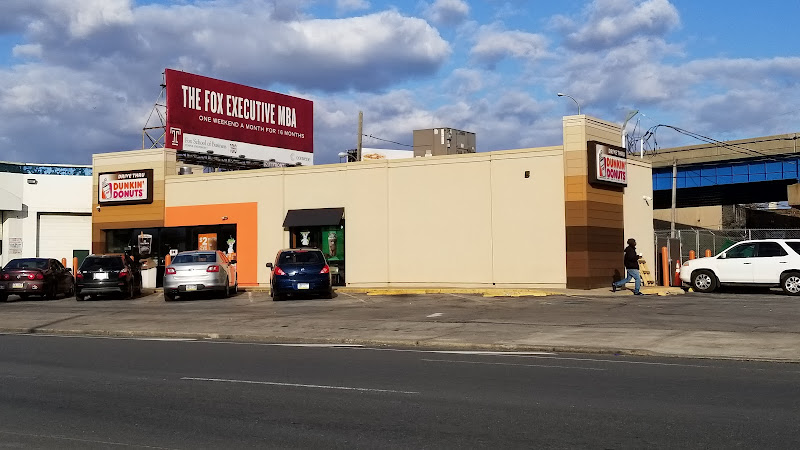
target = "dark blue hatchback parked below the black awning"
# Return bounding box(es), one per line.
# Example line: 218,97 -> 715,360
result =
267,248 -> 333,301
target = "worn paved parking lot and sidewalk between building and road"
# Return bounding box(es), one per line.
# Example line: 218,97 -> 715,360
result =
0,288 -> 800,362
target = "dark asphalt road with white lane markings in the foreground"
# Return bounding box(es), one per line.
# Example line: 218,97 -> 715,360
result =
0,335 -> 800,449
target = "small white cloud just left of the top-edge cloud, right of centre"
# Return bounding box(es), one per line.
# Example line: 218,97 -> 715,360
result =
470,26 -> 548,65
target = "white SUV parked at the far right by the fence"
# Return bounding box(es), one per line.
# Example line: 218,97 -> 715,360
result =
681,239 -> 800,295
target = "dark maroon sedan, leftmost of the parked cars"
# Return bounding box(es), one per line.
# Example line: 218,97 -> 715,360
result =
0,258 -> 75,301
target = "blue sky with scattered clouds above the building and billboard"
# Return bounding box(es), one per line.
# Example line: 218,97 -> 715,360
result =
0,0 -> 800,164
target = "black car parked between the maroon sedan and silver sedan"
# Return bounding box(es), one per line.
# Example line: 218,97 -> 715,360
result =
75,254 -> 142,301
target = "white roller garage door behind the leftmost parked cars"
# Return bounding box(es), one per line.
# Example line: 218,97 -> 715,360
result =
38,214 -> 92,268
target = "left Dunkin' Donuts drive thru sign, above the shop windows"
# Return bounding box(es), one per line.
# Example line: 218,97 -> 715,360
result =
97,169 -> 153,205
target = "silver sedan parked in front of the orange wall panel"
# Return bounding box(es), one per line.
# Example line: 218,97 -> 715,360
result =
164,250 -> 239,301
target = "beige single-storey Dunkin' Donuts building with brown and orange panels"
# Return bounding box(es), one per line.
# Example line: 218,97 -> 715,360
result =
93,116 -> 654,288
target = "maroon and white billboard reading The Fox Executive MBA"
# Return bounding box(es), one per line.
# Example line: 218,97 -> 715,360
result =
164,69 -> 314,165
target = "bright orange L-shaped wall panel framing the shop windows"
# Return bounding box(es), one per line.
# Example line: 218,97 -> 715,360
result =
164,202 -> 258,285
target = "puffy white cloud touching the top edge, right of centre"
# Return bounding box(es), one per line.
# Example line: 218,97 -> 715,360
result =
555,0 -> 680,50
